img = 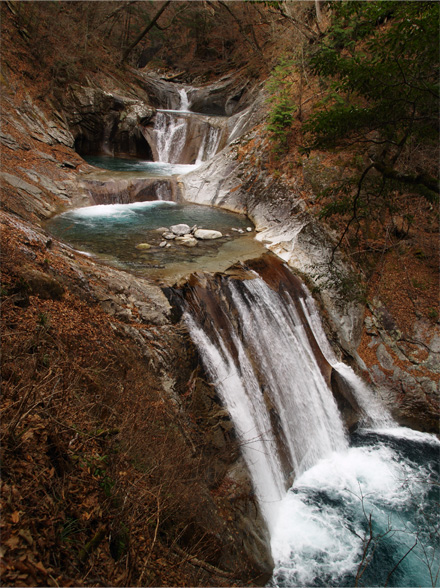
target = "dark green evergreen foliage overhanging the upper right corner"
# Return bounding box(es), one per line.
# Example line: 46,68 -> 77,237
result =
305,1 -> 440,204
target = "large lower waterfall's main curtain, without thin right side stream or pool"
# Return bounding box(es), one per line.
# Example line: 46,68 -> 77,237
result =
179,258 -> 354,529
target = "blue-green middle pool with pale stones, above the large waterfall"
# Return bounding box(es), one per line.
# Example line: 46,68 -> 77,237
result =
46,201 -> 265,281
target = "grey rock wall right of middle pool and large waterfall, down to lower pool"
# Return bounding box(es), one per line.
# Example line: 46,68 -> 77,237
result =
182,139 -> 440,432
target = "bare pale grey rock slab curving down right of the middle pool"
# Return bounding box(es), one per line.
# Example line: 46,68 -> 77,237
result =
182,145 -> 363,357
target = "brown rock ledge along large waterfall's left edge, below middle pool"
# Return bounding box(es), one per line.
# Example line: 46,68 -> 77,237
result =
0,212 -> 273,585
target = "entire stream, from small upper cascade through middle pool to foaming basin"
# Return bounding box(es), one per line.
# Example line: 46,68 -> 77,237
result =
47,89 -> 440,586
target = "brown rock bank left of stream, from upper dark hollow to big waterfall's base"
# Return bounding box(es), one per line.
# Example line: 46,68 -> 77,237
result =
0,68 -> 273,584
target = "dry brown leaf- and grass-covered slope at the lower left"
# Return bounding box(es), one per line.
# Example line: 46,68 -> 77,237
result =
1,218 -> 241,586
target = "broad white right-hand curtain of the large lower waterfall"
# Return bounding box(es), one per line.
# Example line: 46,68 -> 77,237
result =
230,278 -> 347,475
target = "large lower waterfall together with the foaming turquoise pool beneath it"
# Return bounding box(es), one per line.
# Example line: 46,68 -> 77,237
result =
180,262 -> 440,586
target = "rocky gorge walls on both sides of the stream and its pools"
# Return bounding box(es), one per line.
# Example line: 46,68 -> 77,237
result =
0,3 -> 440,585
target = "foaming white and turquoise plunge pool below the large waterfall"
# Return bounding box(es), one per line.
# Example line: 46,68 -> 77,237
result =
271,428 -> 440,586
